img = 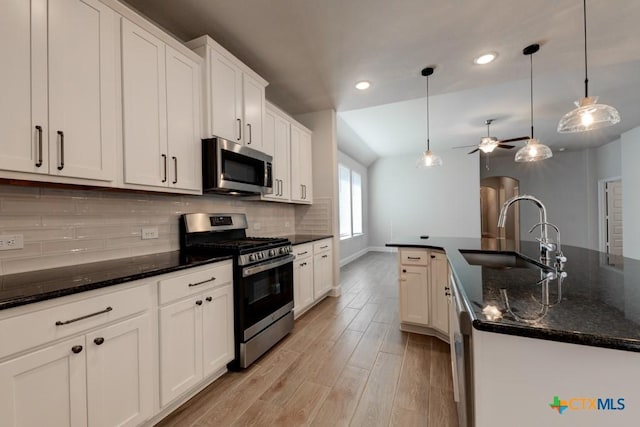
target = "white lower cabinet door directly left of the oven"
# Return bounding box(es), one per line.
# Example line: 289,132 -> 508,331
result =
202,285 -> 235,377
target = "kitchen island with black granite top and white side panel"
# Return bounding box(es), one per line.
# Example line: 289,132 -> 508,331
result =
387,236 -> 640,426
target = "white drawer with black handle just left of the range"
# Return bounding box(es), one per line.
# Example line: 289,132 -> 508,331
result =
158,260 -> 233,304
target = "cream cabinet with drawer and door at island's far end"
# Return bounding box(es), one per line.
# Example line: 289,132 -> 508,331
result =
398,248 -> 449,339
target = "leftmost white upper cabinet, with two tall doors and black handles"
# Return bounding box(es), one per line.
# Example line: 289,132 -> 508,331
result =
0,0 -> 116,181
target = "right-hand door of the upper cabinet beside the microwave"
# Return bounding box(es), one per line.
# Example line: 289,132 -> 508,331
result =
166,46 -> 202,190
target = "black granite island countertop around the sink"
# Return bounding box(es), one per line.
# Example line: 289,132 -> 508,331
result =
387,236 -> 640,352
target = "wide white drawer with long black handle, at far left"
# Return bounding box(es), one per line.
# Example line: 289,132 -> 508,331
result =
0,283 -> 154,358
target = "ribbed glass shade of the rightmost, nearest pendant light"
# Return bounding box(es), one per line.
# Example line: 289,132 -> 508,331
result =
558,96 -> 620,133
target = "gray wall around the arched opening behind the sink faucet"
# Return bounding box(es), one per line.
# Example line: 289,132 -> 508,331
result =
480,141 -> 626,255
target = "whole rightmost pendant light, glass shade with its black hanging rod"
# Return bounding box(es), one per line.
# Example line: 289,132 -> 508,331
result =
558,0 -> 620,133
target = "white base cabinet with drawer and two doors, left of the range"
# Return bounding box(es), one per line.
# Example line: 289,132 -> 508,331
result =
159,262 -> 235,406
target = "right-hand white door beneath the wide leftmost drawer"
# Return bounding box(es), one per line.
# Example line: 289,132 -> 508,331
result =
86,312 -> 154,427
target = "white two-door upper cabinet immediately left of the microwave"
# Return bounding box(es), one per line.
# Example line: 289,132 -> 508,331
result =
122,19 -> 202,191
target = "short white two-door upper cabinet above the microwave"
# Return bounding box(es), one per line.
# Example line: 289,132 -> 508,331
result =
187,36 -> 268,151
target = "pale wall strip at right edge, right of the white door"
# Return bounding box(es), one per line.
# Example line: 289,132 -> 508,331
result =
621,127 -> 640,259
